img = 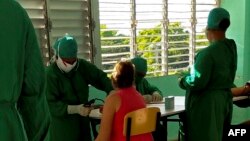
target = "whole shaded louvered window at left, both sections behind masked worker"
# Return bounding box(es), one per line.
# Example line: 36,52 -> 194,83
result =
18,0 -> 94,65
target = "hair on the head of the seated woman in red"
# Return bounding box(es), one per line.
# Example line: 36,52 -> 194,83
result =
111,61 -> 135,88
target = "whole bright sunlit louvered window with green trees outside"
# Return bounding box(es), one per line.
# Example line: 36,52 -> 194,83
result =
99,0 -> 218,76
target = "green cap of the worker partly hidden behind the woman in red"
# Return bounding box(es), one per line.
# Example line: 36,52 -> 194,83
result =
131,57 -> 147,73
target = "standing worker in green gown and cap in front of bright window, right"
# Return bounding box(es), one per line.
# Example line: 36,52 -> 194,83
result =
180,8 -> 237,141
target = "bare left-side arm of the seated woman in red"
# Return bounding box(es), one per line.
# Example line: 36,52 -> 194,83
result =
95,91 -> 121,141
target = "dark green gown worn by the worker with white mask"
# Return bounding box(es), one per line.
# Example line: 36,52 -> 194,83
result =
47,59 -> 113,141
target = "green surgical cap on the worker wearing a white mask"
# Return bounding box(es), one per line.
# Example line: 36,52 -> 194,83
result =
53,35 -> 77,58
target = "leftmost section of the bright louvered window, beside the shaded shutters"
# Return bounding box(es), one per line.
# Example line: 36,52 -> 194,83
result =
99,0 -> 133,73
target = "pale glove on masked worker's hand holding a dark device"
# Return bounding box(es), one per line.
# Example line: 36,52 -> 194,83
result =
67,104 -> 93,116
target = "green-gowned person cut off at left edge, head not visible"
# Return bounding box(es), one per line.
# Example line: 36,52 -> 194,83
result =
0,0 -> 51,141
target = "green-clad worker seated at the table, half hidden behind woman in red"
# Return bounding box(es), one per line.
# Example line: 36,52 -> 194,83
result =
131,56 -> 162,103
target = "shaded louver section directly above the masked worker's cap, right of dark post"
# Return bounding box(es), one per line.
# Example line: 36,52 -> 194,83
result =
48,0 -> 92,61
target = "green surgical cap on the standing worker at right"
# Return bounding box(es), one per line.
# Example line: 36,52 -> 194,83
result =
207,8 -> 230,29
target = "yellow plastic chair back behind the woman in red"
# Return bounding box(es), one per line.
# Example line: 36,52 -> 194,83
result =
123,107 -> 161,141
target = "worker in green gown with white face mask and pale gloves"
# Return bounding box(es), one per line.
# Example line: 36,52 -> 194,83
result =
47,35 -> 113,141
